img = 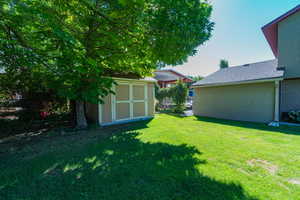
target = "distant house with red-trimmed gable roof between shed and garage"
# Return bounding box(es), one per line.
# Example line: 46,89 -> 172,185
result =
154,69 -> 193,88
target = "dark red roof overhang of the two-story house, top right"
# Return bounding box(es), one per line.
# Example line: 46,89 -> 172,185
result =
262,5 -> 300,57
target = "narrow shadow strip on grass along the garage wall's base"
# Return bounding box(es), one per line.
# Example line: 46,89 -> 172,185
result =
196,116 -> 300,136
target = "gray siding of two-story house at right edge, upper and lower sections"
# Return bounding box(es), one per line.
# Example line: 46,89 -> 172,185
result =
278,12 -> 300,117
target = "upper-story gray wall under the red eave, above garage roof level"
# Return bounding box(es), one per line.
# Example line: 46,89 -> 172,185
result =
278,12 -> 300,78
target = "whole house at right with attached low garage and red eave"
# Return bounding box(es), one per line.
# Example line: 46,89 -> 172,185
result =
193,5 -> 300,122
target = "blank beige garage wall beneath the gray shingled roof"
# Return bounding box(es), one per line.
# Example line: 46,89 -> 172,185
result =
193,82 -> 275,123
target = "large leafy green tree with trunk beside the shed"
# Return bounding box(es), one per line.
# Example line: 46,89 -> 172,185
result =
0,0 -> 213,127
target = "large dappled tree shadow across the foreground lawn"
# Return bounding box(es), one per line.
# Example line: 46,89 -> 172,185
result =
0,131 -> 256,200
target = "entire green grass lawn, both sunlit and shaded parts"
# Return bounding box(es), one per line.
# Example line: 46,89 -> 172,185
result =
0,114 -> 300,200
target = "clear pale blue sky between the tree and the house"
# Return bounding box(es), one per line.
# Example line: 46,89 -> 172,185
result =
168,0 -> 300,76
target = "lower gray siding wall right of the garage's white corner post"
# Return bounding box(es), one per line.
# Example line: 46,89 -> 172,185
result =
280,78 -> 300,112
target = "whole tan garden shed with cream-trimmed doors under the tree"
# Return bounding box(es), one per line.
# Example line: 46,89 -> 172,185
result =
86,78 -> 156,126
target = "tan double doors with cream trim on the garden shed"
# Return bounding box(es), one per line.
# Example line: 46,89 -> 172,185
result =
112,83 -> 148,121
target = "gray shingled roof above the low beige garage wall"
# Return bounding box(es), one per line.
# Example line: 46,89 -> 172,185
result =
193,59 -> 284,86
